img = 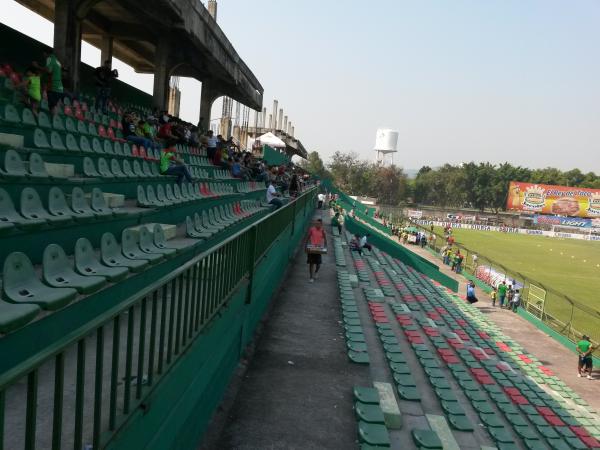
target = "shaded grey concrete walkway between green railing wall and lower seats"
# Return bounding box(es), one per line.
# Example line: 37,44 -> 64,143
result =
202,213 -> 370,450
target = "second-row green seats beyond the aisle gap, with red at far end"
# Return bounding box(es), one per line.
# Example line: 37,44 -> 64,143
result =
137,183 -> 235,208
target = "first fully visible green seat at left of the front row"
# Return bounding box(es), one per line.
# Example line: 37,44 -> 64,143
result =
2,252 -> 77,310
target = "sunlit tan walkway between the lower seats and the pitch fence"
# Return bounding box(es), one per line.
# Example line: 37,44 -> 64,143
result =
396,239 -> 600,410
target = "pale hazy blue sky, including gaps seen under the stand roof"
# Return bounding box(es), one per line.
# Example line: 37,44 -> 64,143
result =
0,0 -> 600,172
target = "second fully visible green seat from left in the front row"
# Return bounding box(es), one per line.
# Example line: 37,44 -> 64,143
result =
42,244 -> 106,294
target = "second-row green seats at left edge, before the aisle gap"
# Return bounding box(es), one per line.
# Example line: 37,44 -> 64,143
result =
0,186 -> 128,231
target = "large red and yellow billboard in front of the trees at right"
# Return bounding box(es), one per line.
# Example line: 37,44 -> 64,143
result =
506,181 -> 600,218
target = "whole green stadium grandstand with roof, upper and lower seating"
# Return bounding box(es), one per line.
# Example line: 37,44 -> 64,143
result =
0,0 -> 600,450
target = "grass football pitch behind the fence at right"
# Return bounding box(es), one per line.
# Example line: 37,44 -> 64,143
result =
436,228 -> 600,336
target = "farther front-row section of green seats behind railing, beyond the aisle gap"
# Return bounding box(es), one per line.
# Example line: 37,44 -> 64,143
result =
185,200 -> 265,239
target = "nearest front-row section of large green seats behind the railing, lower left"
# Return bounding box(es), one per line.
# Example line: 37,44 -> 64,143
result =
0,224 -> 187,333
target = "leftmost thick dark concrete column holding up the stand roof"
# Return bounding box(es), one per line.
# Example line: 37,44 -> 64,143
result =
54,0 -> 81,91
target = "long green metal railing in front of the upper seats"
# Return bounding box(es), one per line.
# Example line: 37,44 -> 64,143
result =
0,188 -> 316,450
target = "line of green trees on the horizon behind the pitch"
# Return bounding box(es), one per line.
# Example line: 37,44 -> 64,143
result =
300,151 -> 600,212
